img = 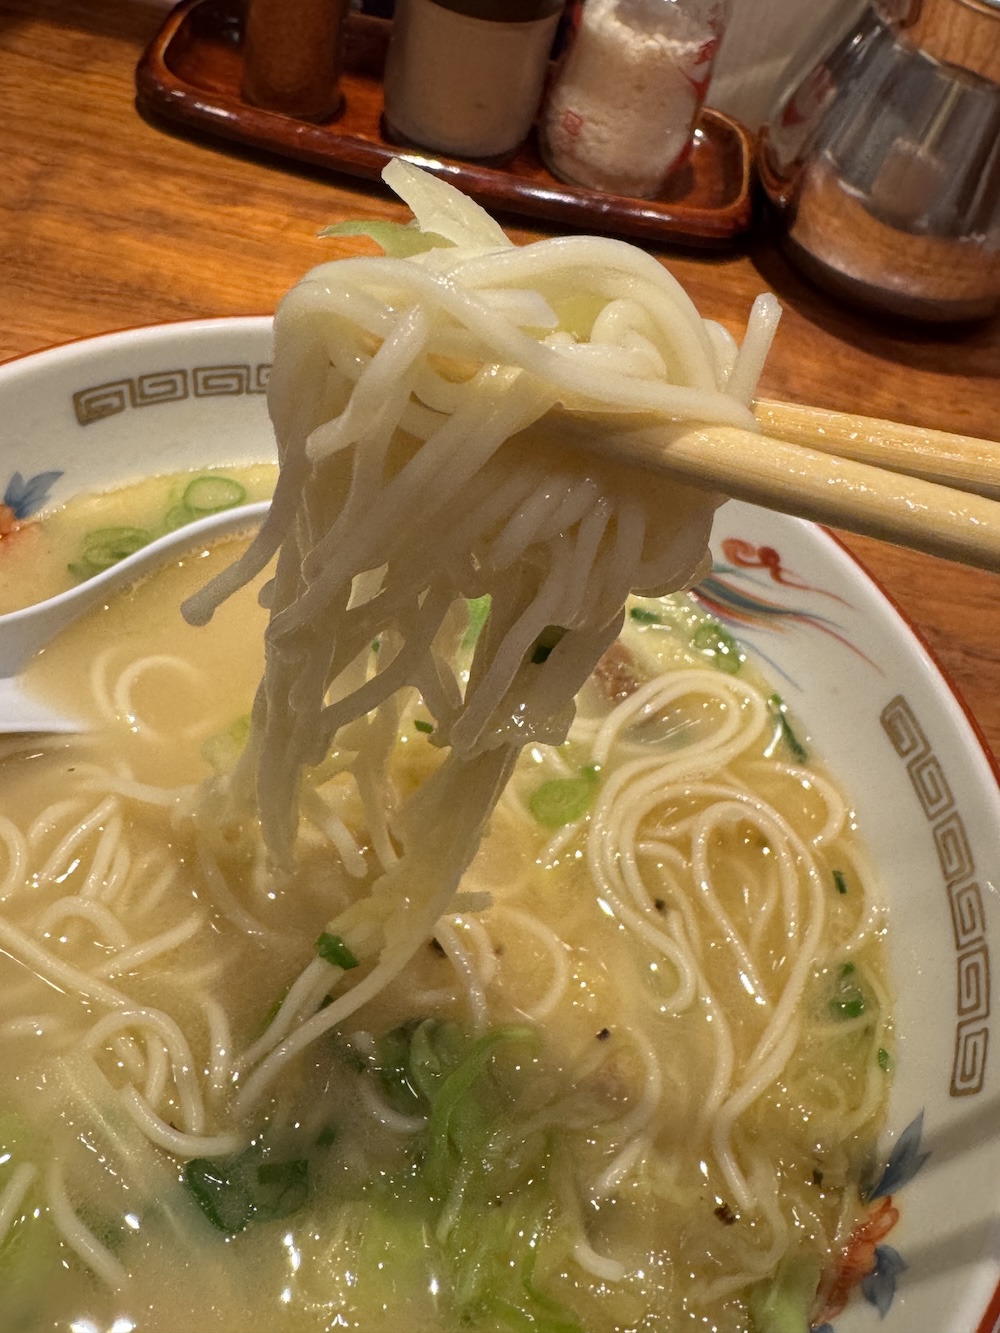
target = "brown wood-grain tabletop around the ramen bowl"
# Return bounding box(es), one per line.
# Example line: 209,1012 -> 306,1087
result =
0,0 -> 1000,754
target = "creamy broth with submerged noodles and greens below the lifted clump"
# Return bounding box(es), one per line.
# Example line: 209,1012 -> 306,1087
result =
0,485 -> 891,1333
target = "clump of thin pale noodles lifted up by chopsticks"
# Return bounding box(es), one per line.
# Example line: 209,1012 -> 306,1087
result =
185,160 -> 777,1093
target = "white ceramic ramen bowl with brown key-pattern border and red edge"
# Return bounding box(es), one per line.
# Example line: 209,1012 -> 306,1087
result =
0,319 -> 1000,1333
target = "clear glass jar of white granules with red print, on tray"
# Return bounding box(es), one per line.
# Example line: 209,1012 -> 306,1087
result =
541,0 -> 725,199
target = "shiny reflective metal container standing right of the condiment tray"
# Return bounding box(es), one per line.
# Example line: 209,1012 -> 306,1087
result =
757,0 -> 1000,320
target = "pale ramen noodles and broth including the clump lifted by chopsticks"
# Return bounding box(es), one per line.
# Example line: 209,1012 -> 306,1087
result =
0,169 -> 889,1333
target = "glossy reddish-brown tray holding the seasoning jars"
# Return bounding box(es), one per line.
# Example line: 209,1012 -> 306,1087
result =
136,0 -> 753,247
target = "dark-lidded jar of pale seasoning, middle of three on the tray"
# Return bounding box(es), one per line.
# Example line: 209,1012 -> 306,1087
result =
384,0 -> 563,157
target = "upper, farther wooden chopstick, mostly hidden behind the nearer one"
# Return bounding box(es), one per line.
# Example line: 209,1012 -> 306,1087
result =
753,399 -> 1000,500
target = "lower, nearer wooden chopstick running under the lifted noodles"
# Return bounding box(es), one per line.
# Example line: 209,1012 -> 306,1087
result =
547,415 -> 1000,572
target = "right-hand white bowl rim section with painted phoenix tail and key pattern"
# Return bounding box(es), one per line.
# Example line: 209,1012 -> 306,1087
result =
712,503 -> 1000,1333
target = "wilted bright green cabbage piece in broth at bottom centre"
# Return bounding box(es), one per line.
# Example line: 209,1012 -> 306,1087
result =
357,1020 -> 583,1333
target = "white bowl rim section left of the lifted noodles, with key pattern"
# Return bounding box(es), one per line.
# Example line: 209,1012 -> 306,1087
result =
0,317 -> 275,517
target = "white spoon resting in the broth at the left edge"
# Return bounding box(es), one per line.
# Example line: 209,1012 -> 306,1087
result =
0,500 -> 271,734
